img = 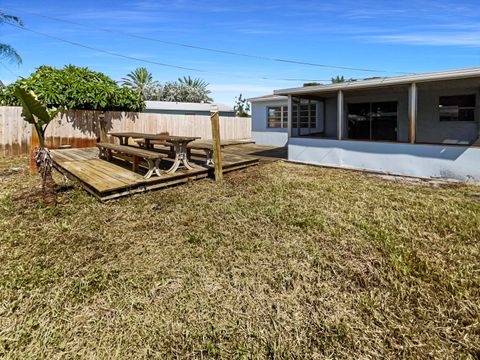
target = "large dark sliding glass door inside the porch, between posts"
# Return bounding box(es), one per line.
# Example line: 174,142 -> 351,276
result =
348,101 -> 397,141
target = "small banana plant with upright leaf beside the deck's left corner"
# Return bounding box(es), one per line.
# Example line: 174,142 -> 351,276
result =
14,86 -> 60,205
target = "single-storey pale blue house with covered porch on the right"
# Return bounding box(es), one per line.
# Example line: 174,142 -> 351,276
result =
250,68 -> 480,183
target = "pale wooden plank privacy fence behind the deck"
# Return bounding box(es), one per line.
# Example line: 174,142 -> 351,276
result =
0,106 -> 252,156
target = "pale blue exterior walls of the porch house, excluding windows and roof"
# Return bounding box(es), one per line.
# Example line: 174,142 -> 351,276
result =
252,78 -> 480,183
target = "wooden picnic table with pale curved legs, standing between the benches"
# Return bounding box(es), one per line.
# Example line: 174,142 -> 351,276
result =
108,132 -> 200,174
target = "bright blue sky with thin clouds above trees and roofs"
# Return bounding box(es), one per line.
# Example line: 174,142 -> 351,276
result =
0,0 -> 480,105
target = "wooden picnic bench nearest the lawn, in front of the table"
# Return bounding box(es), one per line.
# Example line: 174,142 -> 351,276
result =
97,143 -> 167,179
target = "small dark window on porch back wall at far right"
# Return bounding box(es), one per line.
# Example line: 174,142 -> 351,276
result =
438,95 -> 475,121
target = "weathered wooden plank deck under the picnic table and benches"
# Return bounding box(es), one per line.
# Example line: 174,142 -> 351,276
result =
51,144 -> 285,200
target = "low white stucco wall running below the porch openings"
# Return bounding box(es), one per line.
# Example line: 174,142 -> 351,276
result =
288,138 -> 480,183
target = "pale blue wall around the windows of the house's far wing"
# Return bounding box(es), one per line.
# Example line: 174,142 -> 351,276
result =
252,100 -> 288,146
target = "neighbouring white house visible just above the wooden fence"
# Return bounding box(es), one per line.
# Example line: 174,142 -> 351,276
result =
143,101 -> 235,117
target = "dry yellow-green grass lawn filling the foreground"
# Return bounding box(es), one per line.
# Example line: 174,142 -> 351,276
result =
0,158 -> 480,359
